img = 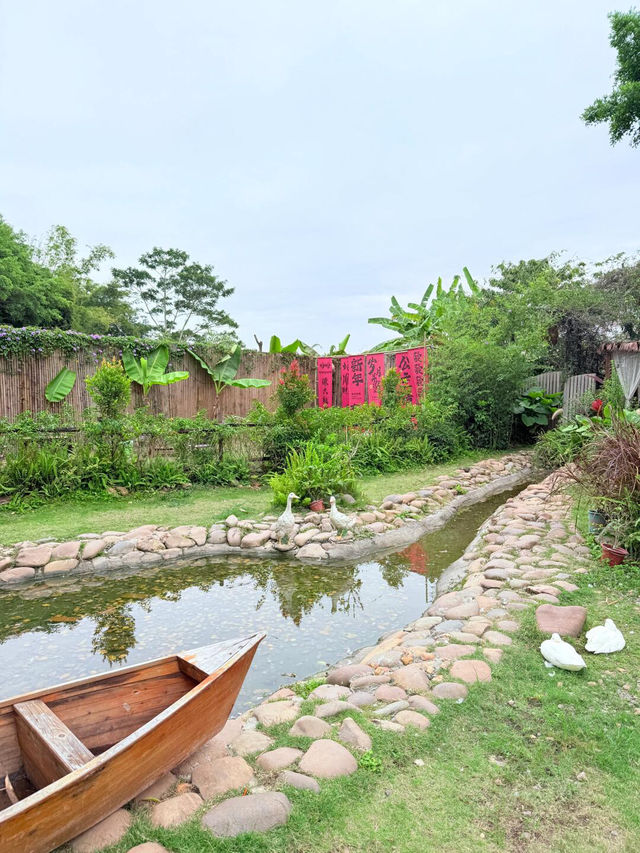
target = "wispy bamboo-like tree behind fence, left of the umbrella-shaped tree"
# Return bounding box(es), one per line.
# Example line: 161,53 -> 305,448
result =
33,225 -> 145,335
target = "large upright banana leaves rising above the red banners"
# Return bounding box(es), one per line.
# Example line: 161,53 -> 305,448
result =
369,267 -> 480,352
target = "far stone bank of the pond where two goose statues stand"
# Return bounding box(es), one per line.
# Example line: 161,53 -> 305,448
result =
0,453 -> 530,585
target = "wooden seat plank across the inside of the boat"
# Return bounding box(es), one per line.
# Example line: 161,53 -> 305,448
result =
13,699 -> 94,788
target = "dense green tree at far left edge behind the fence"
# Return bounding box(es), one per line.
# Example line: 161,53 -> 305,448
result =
0,217 -> 73,329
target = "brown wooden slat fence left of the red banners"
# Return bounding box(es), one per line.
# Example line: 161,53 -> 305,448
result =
0,351 -> 316,420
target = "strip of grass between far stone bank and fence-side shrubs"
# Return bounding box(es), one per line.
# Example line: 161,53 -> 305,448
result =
0,446 -> 501,545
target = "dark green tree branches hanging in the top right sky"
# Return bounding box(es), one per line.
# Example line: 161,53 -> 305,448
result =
582,9 -> 640,147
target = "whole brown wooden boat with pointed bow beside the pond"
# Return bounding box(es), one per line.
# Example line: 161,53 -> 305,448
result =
0,634 -> 264,853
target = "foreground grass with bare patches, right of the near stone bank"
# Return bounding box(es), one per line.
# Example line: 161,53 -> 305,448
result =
86,500 -> 640,853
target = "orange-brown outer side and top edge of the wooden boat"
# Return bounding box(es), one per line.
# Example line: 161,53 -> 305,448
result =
0,635 -> 262,853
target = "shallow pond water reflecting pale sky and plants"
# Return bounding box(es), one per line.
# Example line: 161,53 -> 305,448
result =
0,492 -> 524,711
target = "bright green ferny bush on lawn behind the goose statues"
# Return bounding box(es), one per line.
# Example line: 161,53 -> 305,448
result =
269,441 -> 356,504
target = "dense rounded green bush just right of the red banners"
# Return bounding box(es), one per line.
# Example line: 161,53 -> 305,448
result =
429,338 -> 530,449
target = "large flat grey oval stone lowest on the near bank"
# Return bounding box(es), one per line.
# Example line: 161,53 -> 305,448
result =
202,791 -> 291,838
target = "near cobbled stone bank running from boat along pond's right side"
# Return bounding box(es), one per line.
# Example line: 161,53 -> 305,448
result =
72,476 -> 590,853
